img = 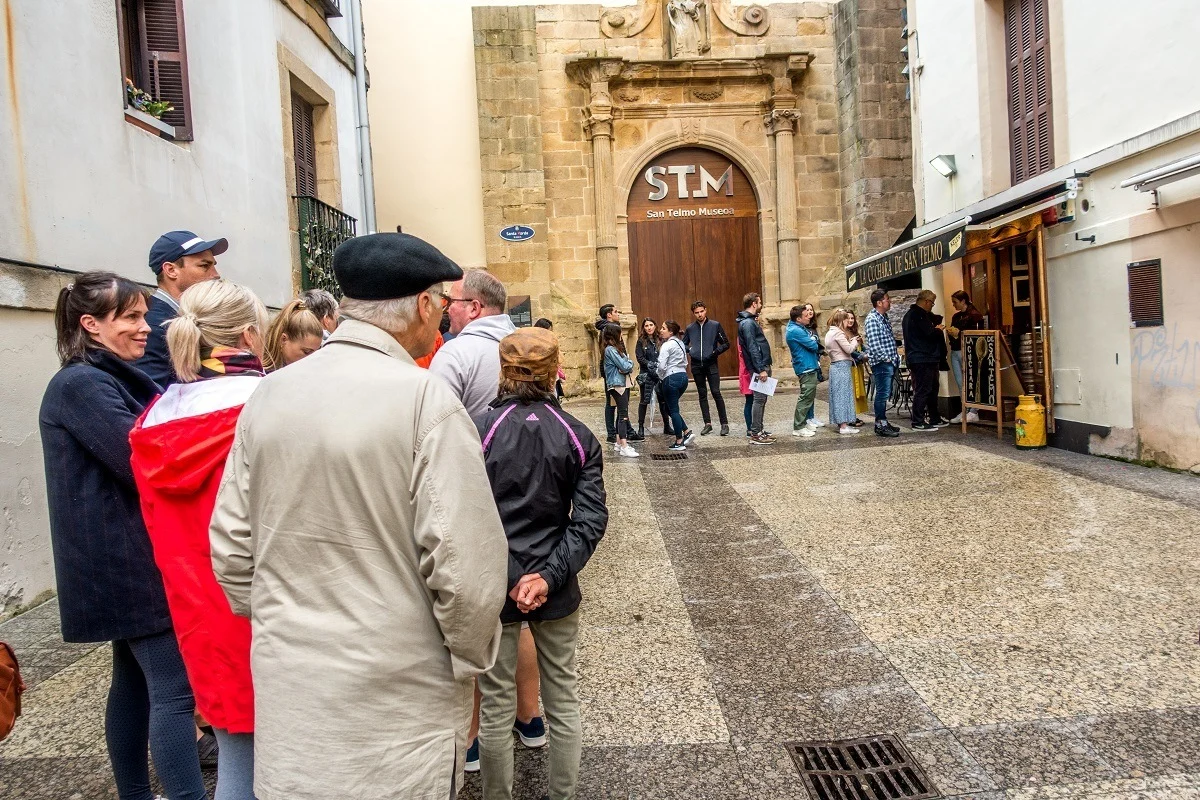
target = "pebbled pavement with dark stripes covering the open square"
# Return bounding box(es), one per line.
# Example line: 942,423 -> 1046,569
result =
0,395 -> 1200,800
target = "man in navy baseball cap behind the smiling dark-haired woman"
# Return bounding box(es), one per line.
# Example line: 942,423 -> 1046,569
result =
134,230 -> 229,389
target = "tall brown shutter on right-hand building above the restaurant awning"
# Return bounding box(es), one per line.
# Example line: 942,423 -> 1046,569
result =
1004,0 -> 1054,185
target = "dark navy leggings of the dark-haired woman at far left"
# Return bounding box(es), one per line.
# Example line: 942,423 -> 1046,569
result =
104,631 -> 208,800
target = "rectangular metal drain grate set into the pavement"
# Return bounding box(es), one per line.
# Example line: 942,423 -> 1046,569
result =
786,735 -> 941,800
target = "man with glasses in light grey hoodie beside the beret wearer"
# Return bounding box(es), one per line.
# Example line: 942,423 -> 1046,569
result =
430,270 -> 516,416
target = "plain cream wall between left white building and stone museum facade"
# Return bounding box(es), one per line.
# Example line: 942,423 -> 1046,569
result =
362,0 -> 825,266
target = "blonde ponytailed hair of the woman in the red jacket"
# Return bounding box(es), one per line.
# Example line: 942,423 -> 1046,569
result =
167,281 -> 266,384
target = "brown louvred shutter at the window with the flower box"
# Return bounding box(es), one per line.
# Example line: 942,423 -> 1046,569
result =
139,0 -> 192,140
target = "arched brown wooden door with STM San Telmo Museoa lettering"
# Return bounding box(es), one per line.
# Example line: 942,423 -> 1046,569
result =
626,148 -> 762,375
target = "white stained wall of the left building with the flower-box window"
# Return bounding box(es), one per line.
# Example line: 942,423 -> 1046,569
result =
0,0 -> 361,614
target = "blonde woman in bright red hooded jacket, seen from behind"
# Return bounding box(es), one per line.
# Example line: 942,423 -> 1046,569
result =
130,281 -> 266,800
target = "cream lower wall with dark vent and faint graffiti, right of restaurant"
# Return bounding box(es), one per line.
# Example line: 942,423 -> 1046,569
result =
1048,134 -> 1200,468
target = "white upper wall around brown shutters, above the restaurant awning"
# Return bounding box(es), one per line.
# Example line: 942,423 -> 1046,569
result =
908,0 -> 1200,223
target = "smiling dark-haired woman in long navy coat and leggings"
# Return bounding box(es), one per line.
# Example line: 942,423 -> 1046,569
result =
40,272 -> 206,800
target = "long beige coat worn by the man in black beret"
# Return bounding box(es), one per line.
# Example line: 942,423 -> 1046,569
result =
210,321 -> 508,800
